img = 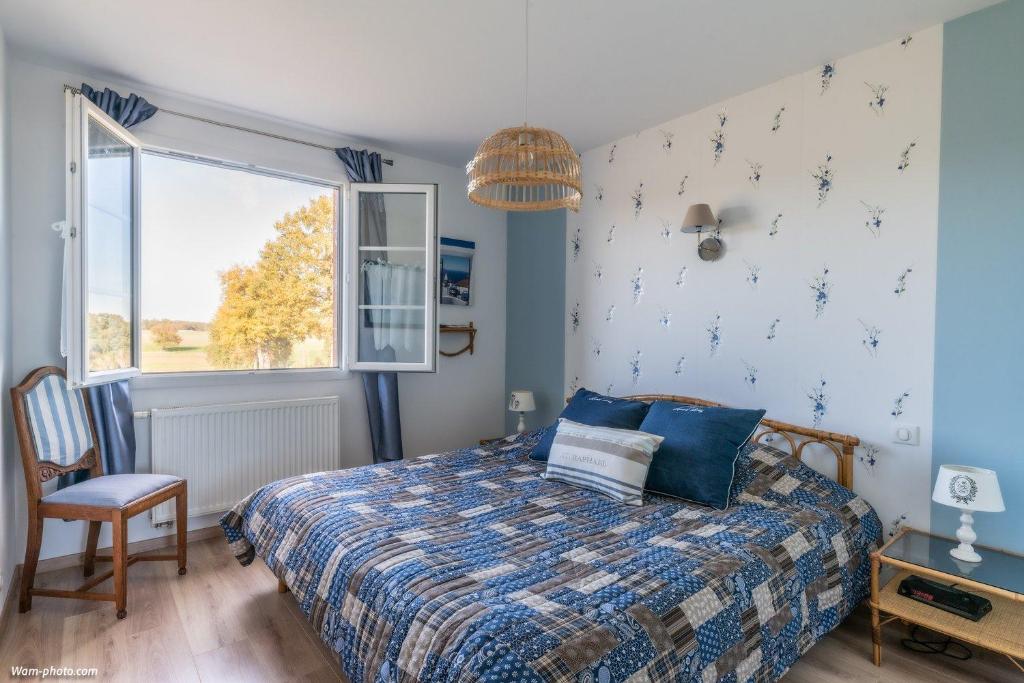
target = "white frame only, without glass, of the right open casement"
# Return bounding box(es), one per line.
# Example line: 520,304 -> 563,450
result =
345,182 -> 438,373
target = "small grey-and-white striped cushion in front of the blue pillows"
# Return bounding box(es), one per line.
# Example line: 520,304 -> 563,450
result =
541,418 -> 665,505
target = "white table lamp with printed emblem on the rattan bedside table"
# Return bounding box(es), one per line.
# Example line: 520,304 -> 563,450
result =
932,465 -> 1007,562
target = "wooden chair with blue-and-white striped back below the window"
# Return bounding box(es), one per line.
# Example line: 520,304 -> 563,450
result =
10,367 -> 187,618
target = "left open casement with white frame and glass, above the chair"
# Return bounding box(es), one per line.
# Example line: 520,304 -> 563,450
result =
61,93 -> 139,386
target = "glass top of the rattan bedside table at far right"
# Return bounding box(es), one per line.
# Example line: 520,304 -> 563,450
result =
882,529 -> 1024,594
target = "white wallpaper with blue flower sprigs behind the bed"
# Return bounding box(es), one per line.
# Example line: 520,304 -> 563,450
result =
565,27 -> 942,528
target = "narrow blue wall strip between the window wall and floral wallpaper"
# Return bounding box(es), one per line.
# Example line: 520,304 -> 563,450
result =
505,210 -> 566,434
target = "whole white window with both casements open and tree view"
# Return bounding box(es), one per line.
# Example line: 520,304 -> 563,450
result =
62,95 -> 437,386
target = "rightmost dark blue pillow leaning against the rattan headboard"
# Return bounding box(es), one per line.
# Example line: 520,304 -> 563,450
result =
639,400 -> 765,510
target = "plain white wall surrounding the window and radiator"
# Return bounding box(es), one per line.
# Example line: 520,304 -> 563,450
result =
9,54 -> 506,557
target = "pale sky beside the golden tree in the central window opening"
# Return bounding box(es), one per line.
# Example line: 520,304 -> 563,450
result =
141,154 -> 333,323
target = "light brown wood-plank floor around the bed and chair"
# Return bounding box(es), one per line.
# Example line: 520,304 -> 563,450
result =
0,539 -> 1024,683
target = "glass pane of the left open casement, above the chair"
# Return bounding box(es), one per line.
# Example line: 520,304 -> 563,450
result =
86,118 -> 132,372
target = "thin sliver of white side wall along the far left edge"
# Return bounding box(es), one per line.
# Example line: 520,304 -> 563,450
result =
0,24 -> 14,600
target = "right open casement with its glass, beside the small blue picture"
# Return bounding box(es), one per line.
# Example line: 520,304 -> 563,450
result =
345,182 -> 437,373
